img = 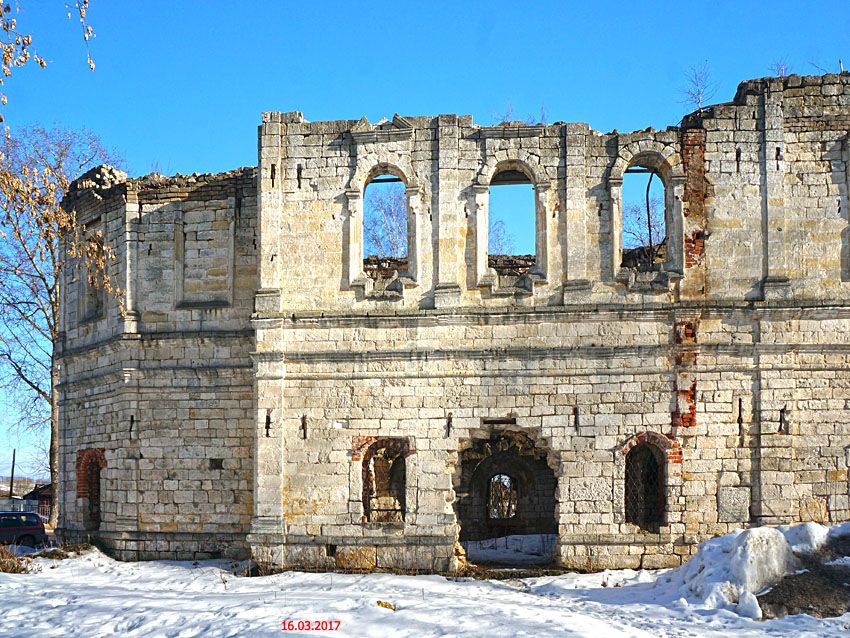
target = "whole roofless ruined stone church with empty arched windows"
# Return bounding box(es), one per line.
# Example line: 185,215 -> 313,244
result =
57,74 -> 850,571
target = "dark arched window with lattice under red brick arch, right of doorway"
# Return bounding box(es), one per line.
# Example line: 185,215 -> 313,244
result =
625,443 -> 666,532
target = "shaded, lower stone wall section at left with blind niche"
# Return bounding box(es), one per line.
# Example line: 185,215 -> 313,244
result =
60,169 -> 257,558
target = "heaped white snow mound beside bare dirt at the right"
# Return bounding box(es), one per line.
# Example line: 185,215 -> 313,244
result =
656,523 -> 828,618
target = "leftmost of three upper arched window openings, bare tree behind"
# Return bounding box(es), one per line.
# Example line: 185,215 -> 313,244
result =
363,173 -> 408,279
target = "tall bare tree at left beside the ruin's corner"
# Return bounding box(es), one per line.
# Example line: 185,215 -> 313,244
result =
0,127 -> 120,522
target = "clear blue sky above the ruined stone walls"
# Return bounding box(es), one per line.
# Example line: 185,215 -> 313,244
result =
0,0 -> 850,474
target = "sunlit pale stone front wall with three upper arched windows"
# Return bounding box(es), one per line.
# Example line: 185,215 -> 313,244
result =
251,76 -> 850,569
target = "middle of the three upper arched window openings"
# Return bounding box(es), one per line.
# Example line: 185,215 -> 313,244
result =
487,169 -> 536,276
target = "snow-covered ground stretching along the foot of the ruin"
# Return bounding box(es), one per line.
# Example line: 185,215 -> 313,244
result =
0,530 -> 850,638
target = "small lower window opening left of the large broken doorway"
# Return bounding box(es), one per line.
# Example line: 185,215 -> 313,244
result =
363,439 -> 407,523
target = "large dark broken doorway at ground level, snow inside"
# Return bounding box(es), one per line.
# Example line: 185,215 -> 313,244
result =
453,430 -> 558,564
